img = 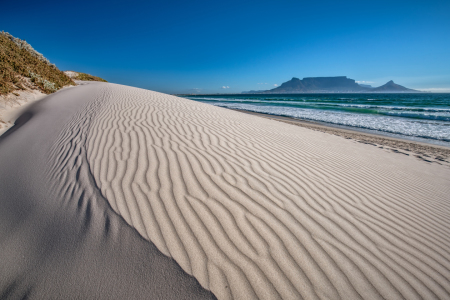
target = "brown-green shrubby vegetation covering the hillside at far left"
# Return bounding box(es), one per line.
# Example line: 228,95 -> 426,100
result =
0,31 -> 75,95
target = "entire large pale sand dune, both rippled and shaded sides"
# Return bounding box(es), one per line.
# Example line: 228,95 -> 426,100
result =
0,83 -> 450,299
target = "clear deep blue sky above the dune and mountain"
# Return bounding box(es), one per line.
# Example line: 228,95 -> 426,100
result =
0,0 -> 450,93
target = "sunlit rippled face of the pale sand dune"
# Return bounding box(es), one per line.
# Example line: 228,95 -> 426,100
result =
44,84 -> 450,299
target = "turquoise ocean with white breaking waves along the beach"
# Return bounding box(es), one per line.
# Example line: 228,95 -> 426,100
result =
185,93 -> 450,147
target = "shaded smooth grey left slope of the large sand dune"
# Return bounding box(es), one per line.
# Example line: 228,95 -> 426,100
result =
0,84 -> 215,300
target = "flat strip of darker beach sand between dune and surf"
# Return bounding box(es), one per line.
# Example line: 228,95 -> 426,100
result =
226,108 -> 450,167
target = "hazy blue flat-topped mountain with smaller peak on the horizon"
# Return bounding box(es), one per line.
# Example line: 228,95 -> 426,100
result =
243,76 -> 419,94
